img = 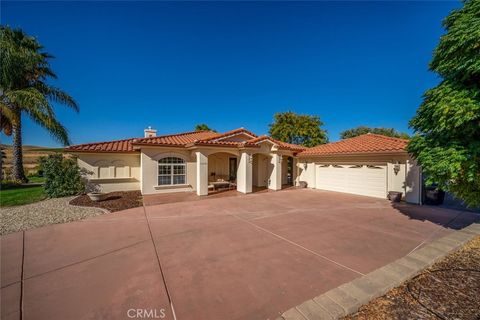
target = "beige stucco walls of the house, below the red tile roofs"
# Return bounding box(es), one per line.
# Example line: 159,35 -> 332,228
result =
71,133 -> 421,203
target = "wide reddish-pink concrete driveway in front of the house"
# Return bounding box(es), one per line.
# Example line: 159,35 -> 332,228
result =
1,190 -> 478,320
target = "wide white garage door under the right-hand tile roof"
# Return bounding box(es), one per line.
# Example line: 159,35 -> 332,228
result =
316,164 -> 387,199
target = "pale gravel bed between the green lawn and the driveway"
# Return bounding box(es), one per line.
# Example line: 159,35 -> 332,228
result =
0,197 -> 106,235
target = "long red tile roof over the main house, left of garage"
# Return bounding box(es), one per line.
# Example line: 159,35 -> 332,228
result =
66,128 -> 305,152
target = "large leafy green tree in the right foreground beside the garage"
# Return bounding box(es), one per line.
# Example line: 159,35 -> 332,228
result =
408,0 -> 480,206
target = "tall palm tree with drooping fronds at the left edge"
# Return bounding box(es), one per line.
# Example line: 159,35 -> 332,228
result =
0,26 -> 79,182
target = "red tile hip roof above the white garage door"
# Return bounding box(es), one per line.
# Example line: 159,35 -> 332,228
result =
299,133 -> 408,156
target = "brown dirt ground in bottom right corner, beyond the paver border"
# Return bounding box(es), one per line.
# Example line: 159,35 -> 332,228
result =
344,237 -> 480,320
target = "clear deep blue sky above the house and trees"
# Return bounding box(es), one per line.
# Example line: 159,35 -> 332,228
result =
1,1 -> 461,146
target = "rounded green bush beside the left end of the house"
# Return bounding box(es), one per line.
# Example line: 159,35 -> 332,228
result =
40,153 -> 85,198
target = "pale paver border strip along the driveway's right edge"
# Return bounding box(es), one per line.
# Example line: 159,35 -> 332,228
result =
277,223 -> 480,320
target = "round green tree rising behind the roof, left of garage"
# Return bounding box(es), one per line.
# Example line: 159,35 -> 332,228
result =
269,111 -> 328,147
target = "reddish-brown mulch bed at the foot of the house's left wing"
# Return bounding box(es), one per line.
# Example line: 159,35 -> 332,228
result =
70,191 -> 142,212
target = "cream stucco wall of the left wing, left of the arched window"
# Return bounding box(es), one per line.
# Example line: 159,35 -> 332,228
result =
76,153 -> 141,192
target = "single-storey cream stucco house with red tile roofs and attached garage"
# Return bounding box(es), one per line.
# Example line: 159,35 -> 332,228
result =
67,127 -> 421,203
